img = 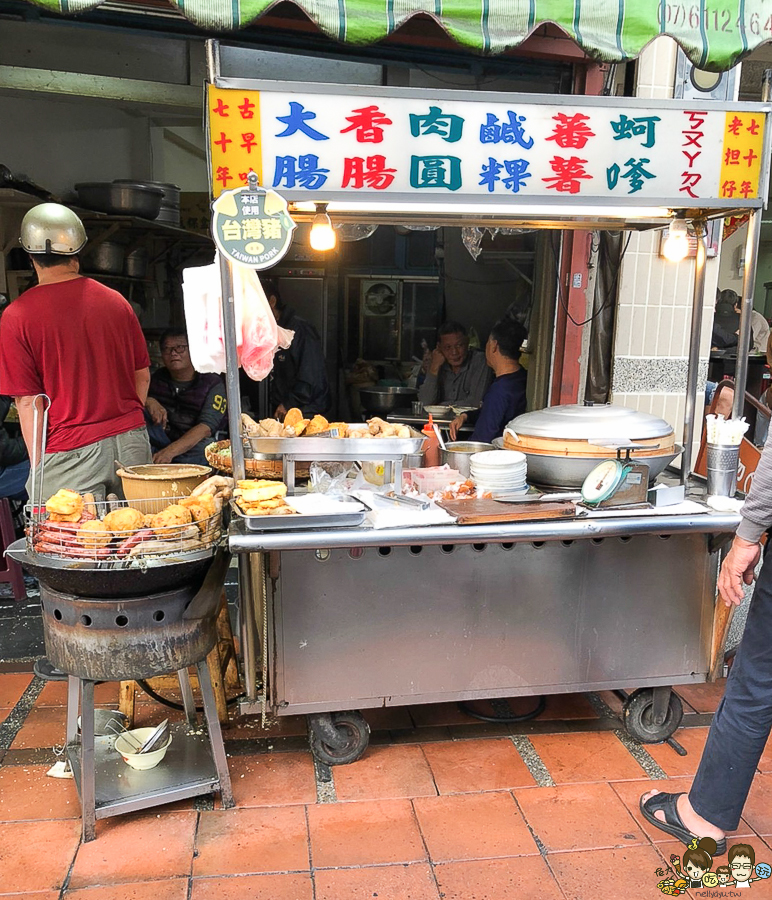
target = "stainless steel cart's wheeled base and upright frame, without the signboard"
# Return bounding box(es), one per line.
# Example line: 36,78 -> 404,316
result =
208,42 -> 770,763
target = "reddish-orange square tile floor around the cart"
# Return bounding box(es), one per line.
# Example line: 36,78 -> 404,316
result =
0,672 -> 772,900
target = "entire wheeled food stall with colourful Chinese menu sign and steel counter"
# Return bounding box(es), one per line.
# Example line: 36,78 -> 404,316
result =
208,45 -> 770,764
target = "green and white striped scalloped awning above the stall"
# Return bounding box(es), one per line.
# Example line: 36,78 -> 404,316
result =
28,0 -> 772,71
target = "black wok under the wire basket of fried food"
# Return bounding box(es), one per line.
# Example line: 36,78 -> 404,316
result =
5,538 -> 214,598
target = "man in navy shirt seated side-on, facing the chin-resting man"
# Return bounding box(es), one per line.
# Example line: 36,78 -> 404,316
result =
450,318 -> 527,443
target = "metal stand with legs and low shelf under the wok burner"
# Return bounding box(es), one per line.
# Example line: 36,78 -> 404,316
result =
67,659 -> 233,843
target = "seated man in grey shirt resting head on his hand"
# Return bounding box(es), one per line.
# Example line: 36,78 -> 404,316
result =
418,322 -> 493,406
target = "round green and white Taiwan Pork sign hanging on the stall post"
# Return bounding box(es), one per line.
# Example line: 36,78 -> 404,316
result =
212,172 -> 295,269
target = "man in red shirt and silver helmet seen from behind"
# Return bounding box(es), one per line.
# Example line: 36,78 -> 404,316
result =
0,203 -> 152,502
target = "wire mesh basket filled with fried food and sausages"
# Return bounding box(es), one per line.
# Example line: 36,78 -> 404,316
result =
26,496 -> 223,566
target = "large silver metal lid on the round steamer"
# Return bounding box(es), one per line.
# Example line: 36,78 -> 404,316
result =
507,403 -> 673,443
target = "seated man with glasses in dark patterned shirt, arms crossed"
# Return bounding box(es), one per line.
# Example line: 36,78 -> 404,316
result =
145,328 -> 227,466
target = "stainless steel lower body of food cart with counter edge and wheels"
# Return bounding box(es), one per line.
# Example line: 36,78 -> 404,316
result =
230,492 -> 739,763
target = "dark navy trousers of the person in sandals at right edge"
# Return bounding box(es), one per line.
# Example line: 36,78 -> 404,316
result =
689,554 -> 772,831
